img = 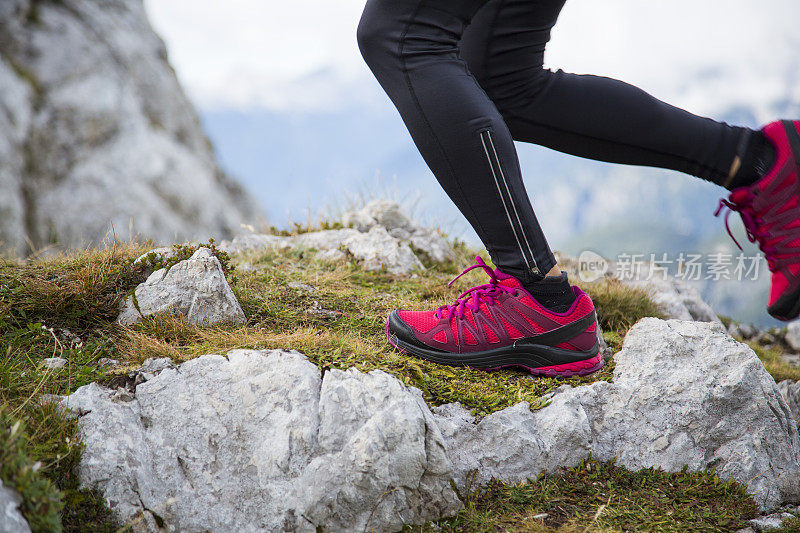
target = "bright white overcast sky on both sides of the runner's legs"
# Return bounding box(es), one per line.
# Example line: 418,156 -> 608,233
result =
145,0 -> 800,115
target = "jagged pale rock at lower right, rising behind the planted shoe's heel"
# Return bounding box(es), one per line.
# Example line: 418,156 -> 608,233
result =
434,318 -> 800,510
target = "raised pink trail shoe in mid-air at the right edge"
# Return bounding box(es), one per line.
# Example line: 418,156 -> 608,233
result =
715,120 -> 800,320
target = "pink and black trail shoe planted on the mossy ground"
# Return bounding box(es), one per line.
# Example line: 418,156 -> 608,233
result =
386,257 -> 603,377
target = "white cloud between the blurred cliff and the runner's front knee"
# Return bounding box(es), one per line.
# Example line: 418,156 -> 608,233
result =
145,0 -> 365,107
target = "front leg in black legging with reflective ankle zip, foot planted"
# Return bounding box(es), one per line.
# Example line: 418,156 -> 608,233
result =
358,0 -> 555,282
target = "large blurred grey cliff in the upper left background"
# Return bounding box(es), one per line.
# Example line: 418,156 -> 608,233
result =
0,0 -> 261,254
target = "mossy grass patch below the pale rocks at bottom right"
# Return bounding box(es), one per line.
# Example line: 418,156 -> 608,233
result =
416,458 -> 756,533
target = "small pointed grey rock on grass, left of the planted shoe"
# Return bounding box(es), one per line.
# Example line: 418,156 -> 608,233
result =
117,248 -> 246,325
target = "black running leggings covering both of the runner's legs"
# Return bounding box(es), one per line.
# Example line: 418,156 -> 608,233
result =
358,0 -> 752,283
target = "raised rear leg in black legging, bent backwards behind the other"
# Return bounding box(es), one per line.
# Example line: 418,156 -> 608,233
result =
461,0 -> 753,184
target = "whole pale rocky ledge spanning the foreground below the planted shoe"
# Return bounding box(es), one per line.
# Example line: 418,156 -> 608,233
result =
63,318 -> 800,531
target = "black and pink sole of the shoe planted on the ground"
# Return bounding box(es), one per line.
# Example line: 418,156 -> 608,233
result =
386,321 -> 603,378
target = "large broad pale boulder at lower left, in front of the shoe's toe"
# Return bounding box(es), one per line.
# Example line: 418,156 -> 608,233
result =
65,350 -> 461,531
